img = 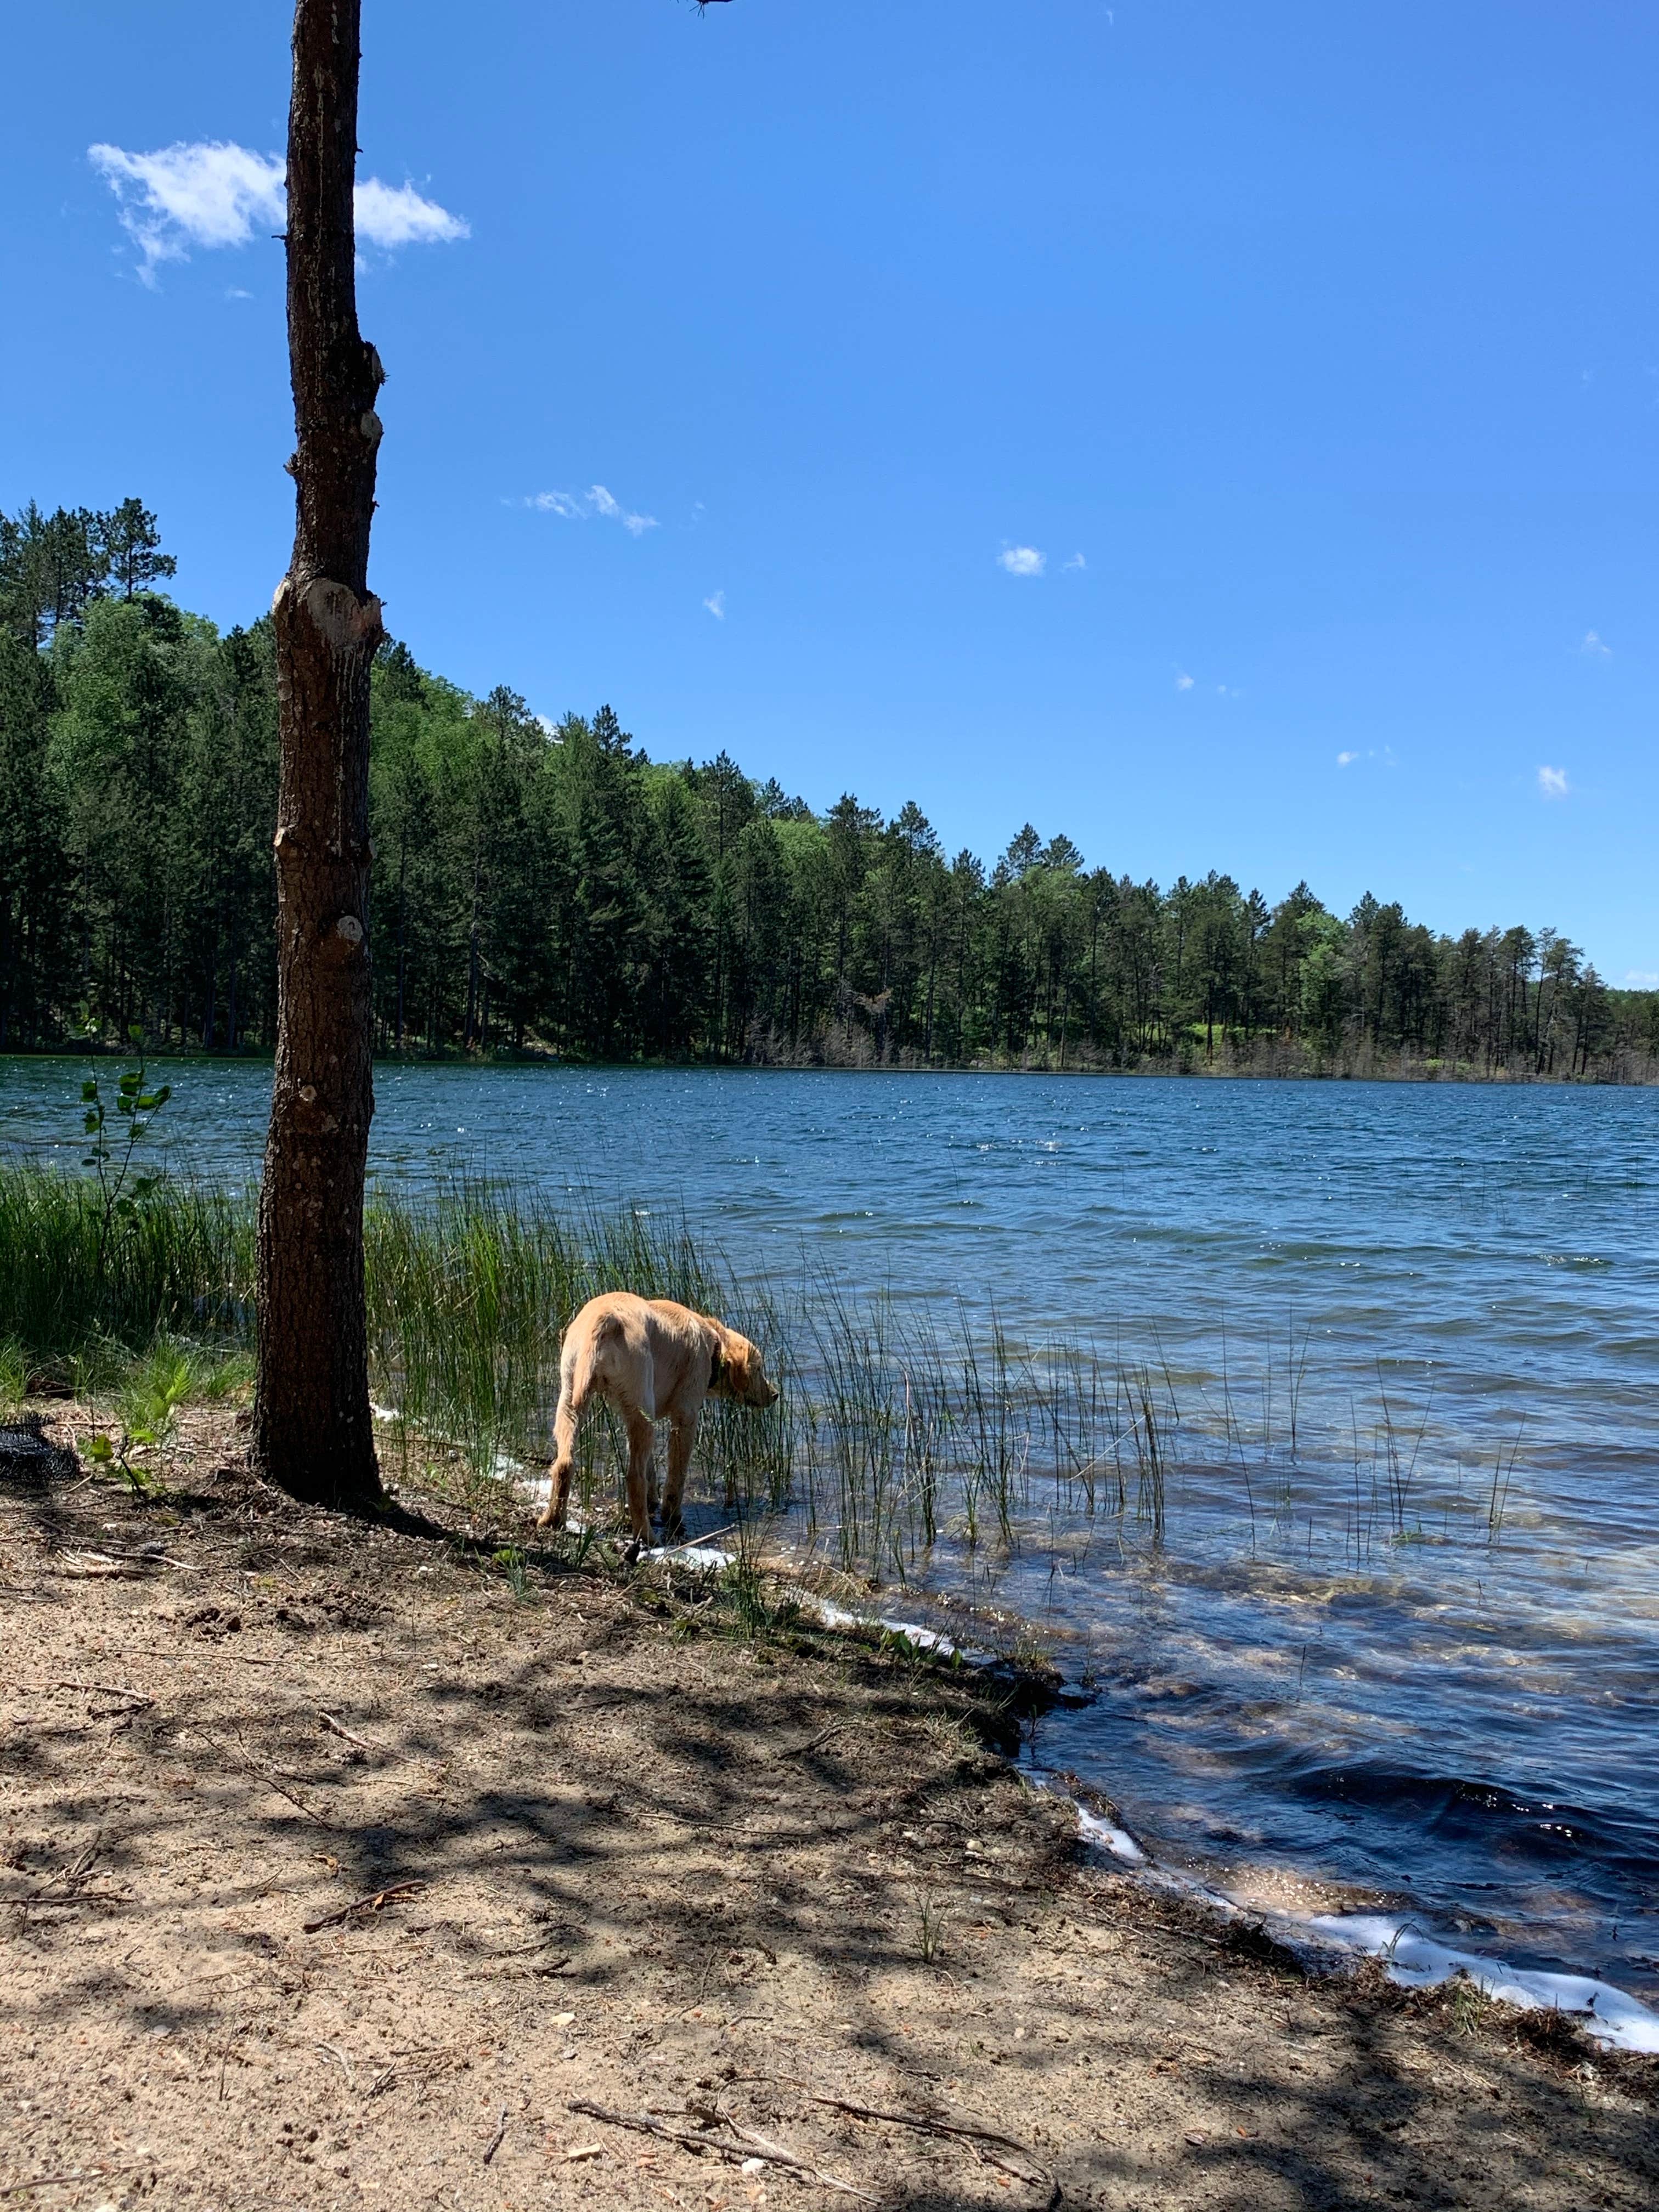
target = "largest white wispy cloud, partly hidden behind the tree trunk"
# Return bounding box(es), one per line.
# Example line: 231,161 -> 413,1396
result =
86,139 -> 471,285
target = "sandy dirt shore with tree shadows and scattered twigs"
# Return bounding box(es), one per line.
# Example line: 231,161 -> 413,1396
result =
0,1409 -> 1659,2212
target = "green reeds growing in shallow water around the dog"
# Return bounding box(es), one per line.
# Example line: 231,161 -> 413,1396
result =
0,1166 -> 1517,1582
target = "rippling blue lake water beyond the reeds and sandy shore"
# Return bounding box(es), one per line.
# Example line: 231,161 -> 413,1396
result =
0,1062 -> 1659,1993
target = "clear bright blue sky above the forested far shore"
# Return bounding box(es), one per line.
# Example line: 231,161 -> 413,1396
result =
0,0 -> 1659,982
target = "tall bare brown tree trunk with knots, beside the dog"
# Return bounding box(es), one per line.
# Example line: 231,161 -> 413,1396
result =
255,0 -> 383,1506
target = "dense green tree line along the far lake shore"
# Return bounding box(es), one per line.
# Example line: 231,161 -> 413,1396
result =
0,500 -> 1659,1080
